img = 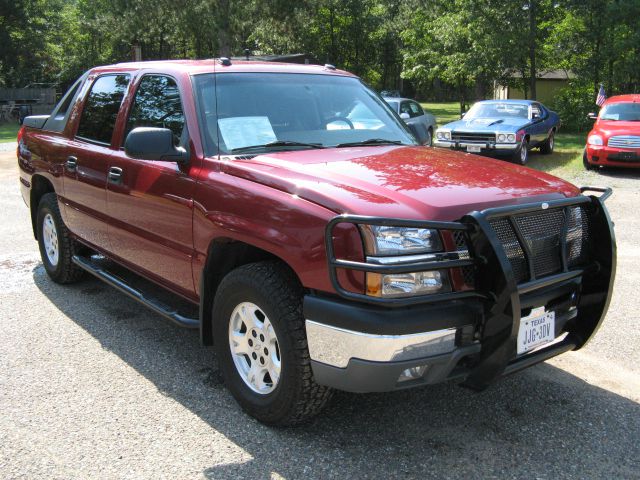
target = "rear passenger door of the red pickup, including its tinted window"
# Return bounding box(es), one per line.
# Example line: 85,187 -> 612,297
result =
64,73 -> 130,251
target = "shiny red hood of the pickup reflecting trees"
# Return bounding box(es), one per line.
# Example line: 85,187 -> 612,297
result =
222,146 -> 580,220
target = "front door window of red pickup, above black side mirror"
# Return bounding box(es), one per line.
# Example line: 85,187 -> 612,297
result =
124,75 -> 187,146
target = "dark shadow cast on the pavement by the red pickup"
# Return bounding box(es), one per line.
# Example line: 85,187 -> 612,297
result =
33,266 -> 640,479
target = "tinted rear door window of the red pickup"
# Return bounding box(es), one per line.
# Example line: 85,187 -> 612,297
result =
77,75 -> 129,145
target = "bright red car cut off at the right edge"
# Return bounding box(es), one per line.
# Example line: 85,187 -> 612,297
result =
582,94 -> 640,170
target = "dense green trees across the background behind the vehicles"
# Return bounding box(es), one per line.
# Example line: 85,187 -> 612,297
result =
0,0 -> 640,102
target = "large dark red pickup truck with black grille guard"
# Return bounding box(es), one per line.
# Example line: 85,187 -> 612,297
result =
18,58 -> 615,425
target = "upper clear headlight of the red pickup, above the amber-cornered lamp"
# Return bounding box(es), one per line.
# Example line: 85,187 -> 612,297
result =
360,225 -> 442,256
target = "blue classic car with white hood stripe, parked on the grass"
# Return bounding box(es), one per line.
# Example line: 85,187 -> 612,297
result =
434,100 -> 560,165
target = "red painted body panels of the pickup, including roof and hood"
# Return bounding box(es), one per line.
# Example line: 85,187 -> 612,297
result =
19,61 -> 579,301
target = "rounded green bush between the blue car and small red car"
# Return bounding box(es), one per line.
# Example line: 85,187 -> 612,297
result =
549,82 -> 599,132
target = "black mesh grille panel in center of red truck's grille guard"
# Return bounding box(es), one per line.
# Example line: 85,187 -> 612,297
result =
489,206 -> 590,283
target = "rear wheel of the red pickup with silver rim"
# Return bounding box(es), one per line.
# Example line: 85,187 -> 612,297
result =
36,193 -> 84,283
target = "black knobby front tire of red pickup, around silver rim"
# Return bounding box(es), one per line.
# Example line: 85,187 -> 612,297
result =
212,261 -> 332,426
